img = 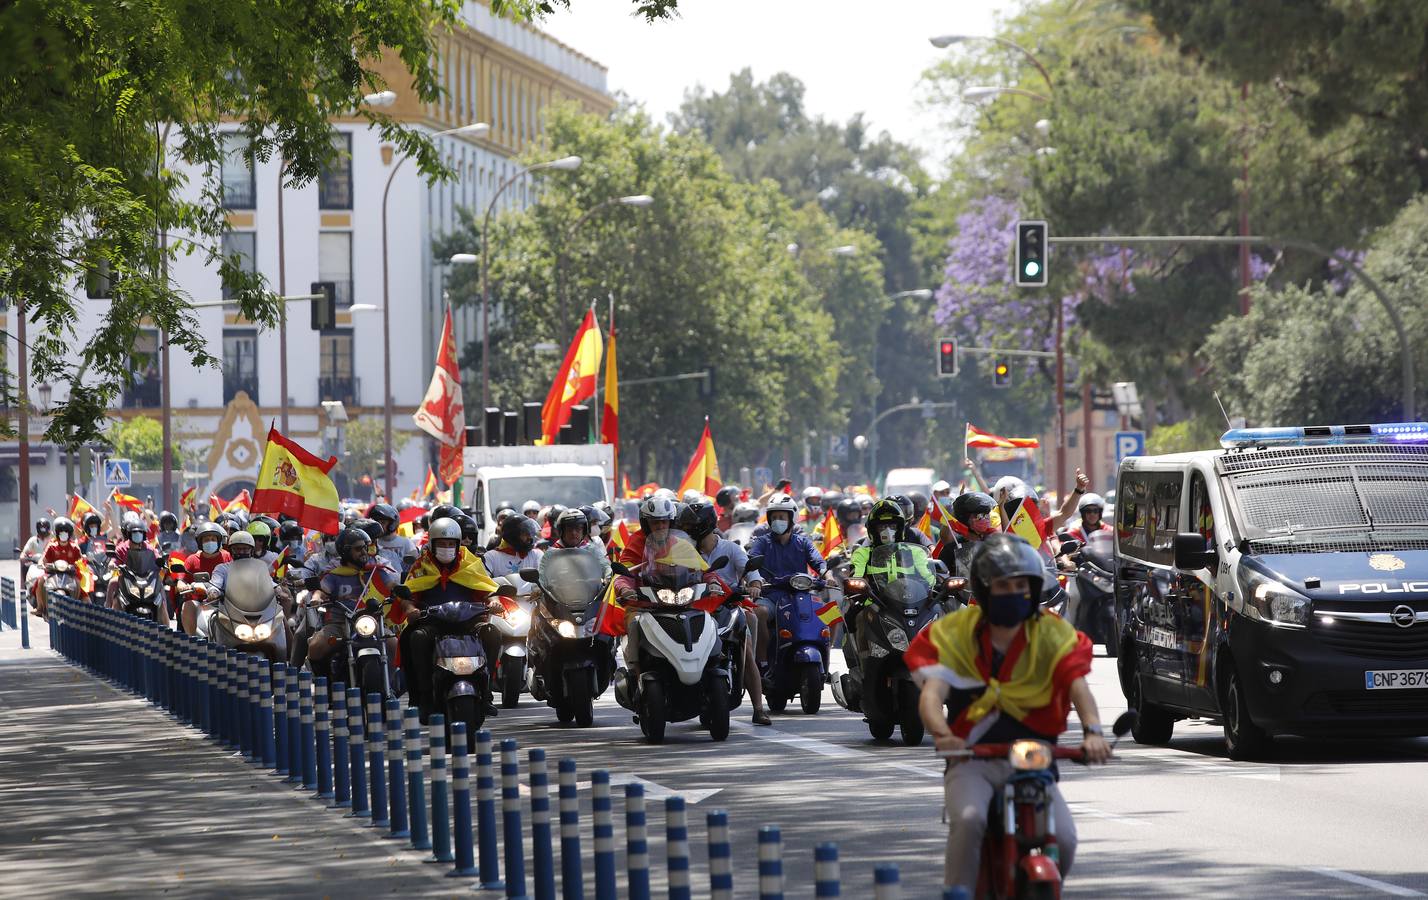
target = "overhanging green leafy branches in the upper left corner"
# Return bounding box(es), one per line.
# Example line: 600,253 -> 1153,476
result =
0,0 -> 458,446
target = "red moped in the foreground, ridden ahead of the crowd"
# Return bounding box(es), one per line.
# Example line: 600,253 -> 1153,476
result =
938,710 -> 1140,900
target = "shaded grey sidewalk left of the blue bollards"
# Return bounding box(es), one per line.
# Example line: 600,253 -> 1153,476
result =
0,563 -> 474,897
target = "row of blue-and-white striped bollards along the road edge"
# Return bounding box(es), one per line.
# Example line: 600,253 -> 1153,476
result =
50,599 -> 948,900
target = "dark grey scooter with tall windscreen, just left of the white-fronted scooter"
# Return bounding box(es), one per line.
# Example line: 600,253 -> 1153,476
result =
520,549 -> 615,729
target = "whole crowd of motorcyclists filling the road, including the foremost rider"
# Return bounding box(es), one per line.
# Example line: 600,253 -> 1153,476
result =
21,471 -> 1114,884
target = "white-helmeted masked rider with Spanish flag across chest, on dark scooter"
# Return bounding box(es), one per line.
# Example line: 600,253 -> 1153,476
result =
396,519 -> 502,723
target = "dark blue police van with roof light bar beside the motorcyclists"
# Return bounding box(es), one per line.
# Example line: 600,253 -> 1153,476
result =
1114,423 -> 1428,759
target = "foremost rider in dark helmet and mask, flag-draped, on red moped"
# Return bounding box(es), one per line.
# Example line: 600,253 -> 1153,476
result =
905,534 -> 1111,886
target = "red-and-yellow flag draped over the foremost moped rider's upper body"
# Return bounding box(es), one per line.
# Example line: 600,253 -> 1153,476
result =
928,606 -> 1091,733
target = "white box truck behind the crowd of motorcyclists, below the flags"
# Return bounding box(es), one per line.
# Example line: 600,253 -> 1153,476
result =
463,444 -> 615,541
